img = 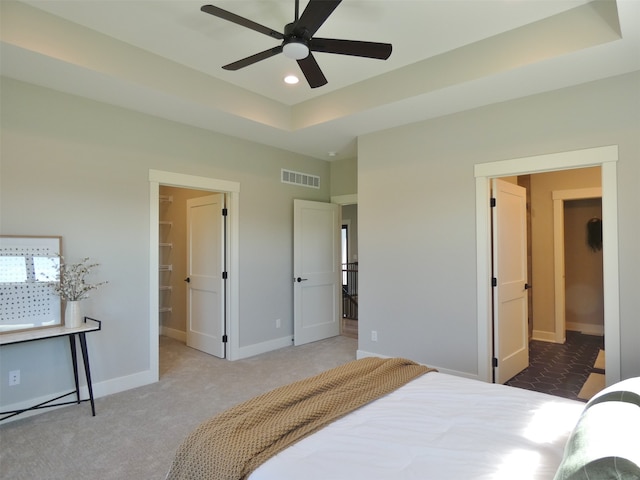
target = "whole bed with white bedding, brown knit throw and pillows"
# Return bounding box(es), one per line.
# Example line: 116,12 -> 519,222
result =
167,359 -> 640,480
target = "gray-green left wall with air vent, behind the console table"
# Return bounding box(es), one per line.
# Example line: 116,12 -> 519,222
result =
0,78 -> 330,406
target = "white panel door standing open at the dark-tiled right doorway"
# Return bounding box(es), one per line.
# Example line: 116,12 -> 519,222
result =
492,179 -> 529,383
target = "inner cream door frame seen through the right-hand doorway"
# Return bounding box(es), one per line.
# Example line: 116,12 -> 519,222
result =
551,187 -> 604,343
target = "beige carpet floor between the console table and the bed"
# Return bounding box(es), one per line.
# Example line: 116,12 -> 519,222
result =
0,336 -> 357,480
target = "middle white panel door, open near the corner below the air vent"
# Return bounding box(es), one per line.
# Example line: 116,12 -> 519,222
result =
293,200 -> 342,345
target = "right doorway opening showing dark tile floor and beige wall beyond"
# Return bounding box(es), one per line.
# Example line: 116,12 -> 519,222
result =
504,174 -> 605,400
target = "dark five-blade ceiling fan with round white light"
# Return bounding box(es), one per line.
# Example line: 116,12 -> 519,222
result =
200,0 -> 391,88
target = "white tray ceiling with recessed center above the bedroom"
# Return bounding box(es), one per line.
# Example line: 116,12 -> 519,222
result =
0,0 -> 640,160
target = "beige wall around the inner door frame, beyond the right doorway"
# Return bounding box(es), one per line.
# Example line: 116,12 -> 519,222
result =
531,167 -> 602,339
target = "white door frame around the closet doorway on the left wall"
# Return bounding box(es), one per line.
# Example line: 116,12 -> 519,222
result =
149,170 -> 240,381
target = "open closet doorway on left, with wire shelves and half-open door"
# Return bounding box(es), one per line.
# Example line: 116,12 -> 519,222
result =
158,185 -> 226,358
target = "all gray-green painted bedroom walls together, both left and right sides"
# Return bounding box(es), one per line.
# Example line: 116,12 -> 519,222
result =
0,70 -> 640,412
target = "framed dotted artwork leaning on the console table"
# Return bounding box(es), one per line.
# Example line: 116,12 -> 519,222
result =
0,235 -> 62,334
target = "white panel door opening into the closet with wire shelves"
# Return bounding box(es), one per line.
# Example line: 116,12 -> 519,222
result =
186,194 -> 225,358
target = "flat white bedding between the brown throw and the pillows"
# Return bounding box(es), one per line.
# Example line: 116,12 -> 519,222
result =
249,372 -> 584,480
